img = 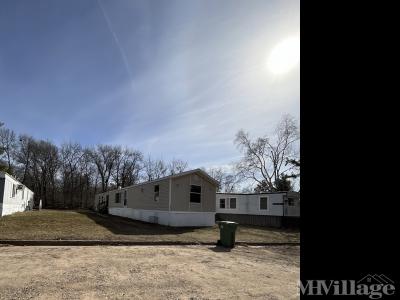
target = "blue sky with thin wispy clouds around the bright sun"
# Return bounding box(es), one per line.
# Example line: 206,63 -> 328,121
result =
0,0 -> 300,167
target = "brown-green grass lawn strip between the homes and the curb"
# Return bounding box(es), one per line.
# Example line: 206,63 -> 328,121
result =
0,210 -> 300,243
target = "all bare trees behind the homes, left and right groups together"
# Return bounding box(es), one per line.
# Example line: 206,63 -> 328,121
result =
0,115 -> 300,208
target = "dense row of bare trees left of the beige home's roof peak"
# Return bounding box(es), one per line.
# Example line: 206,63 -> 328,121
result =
0,123 -> 188,208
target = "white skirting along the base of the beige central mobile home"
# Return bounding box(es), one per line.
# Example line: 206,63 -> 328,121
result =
108,207 -> 215,227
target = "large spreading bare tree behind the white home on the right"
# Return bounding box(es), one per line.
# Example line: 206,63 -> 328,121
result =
235,115 -> 299,191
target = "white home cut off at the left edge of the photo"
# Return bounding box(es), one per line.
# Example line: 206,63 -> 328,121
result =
0,172 -> 34,217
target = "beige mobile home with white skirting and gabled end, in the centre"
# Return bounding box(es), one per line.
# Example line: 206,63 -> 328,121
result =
95,169 -> 218,227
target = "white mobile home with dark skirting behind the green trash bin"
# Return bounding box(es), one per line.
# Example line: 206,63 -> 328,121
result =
216,192 -> 300,227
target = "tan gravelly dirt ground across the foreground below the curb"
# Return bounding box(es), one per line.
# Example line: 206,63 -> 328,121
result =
0,246 -> 300,299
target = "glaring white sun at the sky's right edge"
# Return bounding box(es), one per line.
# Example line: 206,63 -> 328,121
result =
267,35 -> 300,75
